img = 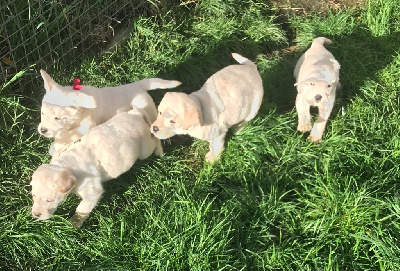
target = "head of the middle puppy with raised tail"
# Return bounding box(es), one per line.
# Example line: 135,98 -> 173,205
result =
150,92 -> 203,139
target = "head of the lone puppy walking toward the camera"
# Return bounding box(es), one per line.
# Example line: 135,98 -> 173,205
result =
295,80 -> 335,107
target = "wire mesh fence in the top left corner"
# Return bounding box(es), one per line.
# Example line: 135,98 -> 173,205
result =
0,0 -> 152,92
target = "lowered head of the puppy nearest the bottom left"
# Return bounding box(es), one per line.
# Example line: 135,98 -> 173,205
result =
31,164 -> 76,220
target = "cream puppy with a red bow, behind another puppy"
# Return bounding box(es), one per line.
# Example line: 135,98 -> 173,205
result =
38,70 -> 181,157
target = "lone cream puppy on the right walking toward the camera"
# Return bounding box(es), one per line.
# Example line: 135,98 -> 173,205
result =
294,37 -> 340,142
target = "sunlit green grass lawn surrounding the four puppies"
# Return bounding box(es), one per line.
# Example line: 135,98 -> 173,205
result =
0,0 -> 400,270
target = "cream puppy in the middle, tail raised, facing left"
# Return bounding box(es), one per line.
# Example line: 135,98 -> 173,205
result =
151,53 -> 264,162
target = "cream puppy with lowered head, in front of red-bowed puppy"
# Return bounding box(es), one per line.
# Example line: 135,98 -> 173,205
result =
31,95 -> 163,228
